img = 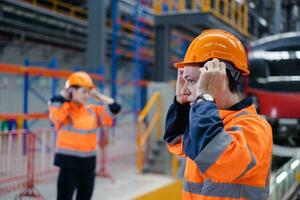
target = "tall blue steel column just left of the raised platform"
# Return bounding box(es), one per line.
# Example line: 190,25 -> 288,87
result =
133,0 -> 141,120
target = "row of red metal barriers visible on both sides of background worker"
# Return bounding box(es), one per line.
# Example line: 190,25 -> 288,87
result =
0,122 -> 136,199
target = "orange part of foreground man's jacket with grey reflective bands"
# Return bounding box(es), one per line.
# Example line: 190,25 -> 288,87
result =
167,102 -> 272,200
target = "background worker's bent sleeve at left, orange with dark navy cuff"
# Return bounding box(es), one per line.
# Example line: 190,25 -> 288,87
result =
48,95 -> 70,130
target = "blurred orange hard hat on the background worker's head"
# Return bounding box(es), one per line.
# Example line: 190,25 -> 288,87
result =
65,71 -> 95,89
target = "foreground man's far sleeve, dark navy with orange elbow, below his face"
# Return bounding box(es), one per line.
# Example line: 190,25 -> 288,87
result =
164,98 -> 190,156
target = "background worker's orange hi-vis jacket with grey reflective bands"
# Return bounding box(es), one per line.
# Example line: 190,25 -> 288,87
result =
49,102 -> 112,158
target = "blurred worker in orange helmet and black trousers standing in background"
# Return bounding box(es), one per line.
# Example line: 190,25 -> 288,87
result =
49,71 -> 121,200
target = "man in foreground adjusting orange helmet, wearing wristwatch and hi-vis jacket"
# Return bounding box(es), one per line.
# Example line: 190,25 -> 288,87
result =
164,29 -> 272,200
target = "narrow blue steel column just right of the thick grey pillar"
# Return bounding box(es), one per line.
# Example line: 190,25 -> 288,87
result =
111,0 -> 119,99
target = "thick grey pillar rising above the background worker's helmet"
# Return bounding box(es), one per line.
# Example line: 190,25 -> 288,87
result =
86,0 -> 106,73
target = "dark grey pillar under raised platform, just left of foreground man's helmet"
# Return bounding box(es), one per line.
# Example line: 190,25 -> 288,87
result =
152,25 -> 176,81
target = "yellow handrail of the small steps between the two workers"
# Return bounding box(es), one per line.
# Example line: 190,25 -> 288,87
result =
137,92 -> 161,174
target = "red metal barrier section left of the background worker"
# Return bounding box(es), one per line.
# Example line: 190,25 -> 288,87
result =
0,129 -> 57,199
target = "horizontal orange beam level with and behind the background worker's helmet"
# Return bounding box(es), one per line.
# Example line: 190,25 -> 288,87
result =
0,63 -> 104,81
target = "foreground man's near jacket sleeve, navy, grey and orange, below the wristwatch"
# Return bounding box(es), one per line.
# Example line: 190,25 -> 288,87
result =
184,101 -> 271,181
